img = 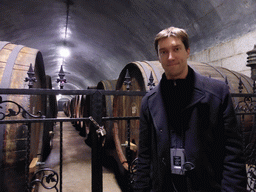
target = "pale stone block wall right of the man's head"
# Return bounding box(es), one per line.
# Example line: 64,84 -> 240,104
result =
189,31 -> 256,77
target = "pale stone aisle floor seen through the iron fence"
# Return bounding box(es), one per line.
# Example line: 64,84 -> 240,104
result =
39,112 -> 121,192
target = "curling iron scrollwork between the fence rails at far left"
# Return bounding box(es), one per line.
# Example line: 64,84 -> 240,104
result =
0,96 -> 45,120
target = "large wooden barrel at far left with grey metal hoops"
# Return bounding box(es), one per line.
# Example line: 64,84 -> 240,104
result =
0,42 -> 46,191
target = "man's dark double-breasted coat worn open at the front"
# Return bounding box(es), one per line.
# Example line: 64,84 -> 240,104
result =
134,68 -> 246,192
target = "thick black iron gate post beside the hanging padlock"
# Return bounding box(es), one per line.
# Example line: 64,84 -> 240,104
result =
90,91 -> 103,192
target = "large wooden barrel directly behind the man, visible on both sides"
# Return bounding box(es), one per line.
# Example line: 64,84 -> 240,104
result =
113,61 -> 253,170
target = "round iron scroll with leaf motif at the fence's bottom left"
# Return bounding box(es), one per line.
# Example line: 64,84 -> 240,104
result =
31,168 -> 59,192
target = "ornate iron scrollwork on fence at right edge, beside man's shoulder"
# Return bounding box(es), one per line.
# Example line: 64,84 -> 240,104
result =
235,97 -> 256,113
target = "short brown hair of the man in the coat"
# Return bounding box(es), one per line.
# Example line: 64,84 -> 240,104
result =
154,27 -> 189,54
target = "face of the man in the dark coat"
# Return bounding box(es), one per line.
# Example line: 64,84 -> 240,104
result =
158,36 -> 190,79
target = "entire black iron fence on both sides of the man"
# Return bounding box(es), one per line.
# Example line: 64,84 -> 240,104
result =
0,89 -> 256,192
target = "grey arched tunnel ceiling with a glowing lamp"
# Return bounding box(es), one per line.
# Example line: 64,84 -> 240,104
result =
0,0 -> 256,89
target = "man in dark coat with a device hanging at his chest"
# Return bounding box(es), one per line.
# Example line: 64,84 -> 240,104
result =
134,27 -> 246,192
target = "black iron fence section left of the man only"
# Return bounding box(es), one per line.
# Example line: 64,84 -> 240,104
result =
0,89 -> 145,192
